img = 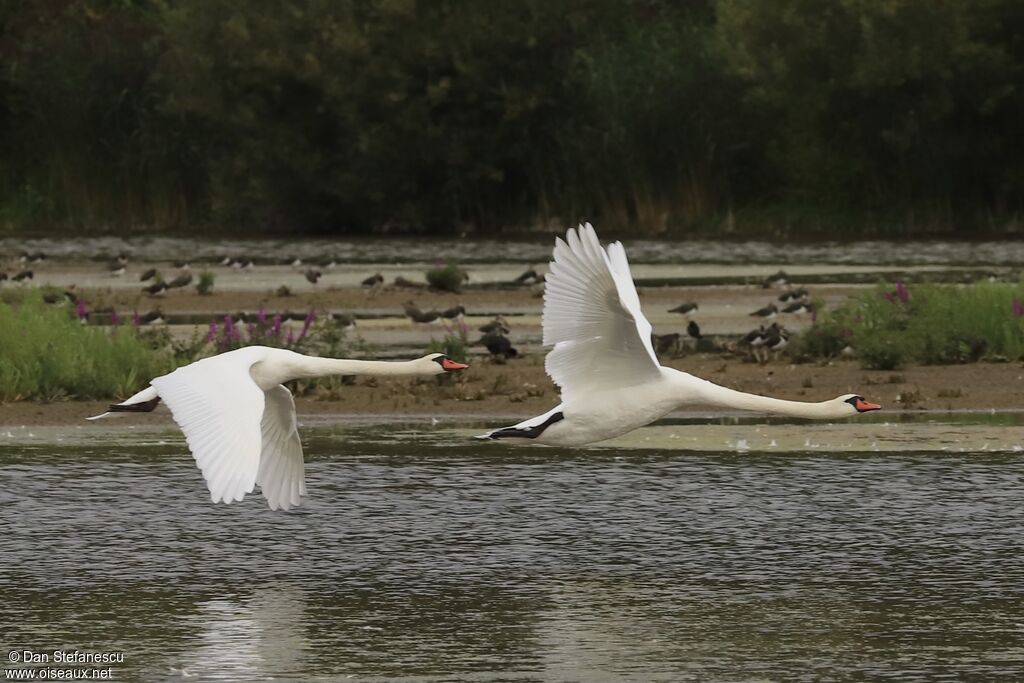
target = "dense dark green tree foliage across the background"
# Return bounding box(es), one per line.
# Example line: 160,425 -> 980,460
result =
0,0 -> 1024,232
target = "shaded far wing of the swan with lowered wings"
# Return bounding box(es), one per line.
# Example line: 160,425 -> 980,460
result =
256,385 -> 306,510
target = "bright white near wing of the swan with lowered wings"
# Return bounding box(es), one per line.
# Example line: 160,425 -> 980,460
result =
151,351 -> 264,503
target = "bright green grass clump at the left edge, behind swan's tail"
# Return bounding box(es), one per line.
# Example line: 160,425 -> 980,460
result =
0,292 -> 173,400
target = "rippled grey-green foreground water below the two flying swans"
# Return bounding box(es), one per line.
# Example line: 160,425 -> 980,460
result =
0,416 -> 1024,681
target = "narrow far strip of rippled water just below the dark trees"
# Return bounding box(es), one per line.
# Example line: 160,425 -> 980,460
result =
6,234 -> 1024,267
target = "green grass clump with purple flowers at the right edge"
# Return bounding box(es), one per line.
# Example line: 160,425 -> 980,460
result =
795,283 -> 1024,370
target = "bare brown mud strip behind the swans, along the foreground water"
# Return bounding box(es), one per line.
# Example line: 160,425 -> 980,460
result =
0,354 -> 1024,426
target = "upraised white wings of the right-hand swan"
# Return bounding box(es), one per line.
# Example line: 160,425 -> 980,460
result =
544,223 -> 660,401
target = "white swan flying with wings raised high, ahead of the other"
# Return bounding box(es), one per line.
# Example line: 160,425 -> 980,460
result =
477,223 -> 881,445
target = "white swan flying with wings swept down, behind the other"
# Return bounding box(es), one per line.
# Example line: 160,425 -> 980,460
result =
87,346 -> 467,510
